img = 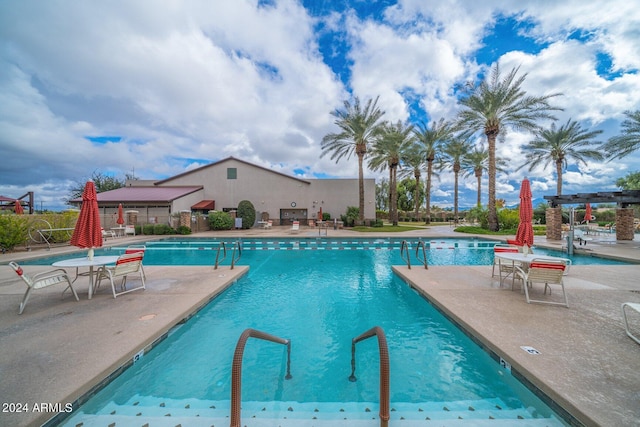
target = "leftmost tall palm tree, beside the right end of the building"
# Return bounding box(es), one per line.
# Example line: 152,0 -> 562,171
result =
320,97 -> 384,223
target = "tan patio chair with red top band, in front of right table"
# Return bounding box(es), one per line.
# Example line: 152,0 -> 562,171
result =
516,258 -> 569,308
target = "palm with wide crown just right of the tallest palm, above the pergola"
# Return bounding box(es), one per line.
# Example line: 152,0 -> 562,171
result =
518,119 -> 604,196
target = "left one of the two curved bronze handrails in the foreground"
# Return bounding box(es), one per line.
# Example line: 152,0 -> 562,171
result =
231,328 -> 292,427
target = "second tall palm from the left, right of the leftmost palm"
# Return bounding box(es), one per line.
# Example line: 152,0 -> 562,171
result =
369,121 -> 413,225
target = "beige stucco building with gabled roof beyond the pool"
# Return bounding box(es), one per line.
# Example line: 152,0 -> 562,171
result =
98,157 -> 375,227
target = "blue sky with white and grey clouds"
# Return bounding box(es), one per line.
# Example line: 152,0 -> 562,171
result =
0,0 -> 640,209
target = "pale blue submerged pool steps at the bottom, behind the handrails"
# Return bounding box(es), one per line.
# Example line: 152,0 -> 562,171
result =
64,396 -> 564,427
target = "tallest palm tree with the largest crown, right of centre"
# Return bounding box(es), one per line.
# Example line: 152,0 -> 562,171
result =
457,64 -> 560,231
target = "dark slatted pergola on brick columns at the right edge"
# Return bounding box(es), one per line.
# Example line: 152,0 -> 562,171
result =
544,190 -> 640,240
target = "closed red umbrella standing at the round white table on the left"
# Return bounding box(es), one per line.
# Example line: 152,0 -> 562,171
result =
70,181 -> 102,259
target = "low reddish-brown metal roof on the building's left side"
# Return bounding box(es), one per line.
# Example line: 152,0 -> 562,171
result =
71,185 -> 203,203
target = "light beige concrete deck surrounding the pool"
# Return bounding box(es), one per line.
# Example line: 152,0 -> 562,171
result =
0,226 -> 640,426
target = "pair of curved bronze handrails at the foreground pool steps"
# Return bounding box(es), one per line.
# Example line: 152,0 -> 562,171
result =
230,326 -> 390,427
